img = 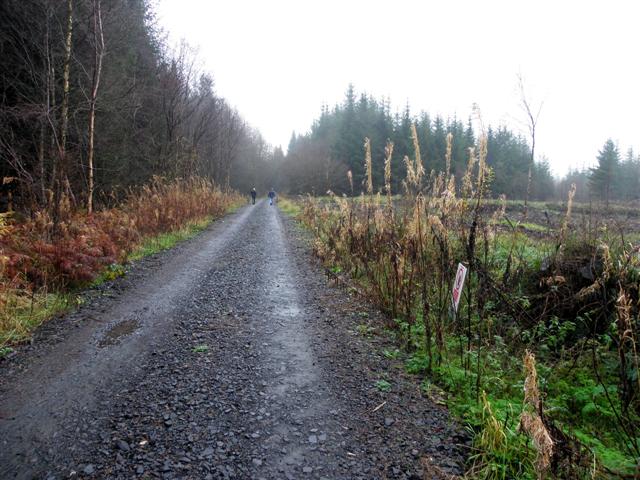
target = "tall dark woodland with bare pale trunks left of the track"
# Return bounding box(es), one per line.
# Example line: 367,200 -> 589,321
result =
0,0 -> 274,213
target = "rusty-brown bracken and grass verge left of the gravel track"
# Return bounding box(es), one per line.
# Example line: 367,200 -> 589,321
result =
0,178 -> 239,348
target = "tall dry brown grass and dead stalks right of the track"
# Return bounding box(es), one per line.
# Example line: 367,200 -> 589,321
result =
302,128 -> 640,478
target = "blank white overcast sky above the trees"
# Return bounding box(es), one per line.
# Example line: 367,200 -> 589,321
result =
156,0 -> 640,174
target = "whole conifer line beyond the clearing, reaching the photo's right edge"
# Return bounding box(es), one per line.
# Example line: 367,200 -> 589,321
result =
276,85 -> 640,201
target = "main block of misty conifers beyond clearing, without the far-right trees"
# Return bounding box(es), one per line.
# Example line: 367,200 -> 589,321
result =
283,85 -> 554,199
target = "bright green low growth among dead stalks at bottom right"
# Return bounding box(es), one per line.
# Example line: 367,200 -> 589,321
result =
405,332 -> 637,478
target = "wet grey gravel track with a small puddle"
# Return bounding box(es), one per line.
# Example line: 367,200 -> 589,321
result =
0,200 -> 467,479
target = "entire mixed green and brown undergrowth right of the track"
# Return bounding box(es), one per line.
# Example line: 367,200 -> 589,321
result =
299,128 -> 640,479
